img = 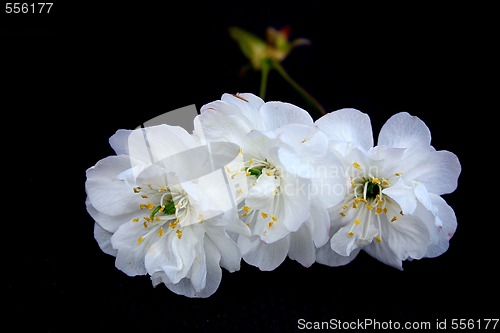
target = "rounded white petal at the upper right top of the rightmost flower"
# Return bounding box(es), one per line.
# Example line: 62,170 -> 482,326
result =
378,112 -> 432,151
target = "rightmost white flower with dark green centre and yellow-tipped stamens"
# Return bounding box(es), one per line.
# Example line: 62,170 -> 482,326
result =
316,109 -> 461,269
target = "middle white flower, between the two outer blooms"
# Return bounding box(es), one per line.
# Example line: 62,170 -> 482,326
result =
195,94 -> 345,270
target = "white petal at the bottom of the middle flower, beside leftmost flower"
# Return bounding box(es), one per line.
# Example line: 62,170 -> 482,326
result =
238,236 -> 290,271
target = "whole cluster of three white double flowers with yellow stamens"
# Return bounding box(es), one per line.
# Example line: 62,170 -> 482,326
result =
85,93 -> 461,297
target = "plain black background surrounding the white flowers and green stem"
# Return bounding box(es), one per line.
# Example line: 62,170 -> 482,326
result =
0,1 -> 500,332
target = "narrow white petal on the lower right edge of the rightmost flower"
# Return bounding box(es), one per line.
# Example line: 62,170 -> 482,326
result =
425,195 -> 457,258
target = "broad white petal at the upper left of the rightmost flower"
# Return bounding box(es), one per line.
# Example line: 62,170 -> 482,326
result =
315,108 -> 373,150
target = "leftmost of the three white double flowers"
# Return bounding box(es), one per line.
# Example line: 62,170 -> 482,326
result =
85,125 -> 248,297
